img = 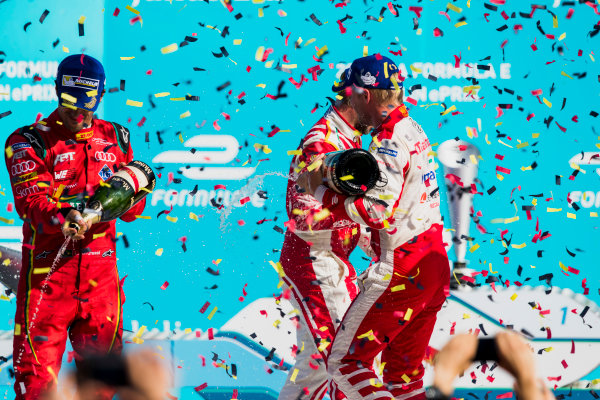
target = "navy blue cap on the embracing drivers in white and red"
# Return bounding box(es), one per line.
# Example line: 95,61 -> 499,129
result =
331,54 -> 402,92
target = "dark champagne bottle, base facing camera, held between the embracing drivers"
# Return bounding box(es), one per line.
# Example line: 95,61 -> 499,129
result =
323,149 -> 379,196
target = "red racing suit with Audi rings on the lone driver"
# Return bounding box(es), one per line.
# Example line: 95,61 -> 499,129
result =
6,111 -> 145,399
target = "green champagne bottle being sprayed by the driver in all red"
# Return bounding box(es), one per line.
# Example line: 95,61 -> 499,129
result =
76,160 -> 156,227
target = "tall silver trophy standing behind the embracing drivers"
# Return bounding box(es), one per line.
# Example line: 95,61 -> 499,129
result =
438,139 -> 479,289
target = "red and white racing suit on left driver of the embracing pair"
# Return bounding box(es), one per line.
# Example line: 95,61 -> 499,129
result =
279,107 -> 361,400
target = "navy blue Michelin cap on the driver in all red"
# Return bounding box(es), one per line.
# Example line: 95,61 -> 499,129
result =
56,54 -> 106,111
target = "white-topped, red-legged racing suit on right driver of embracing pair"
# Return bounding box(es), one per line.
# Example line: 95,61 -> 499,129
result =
315,105 -> 450,400
